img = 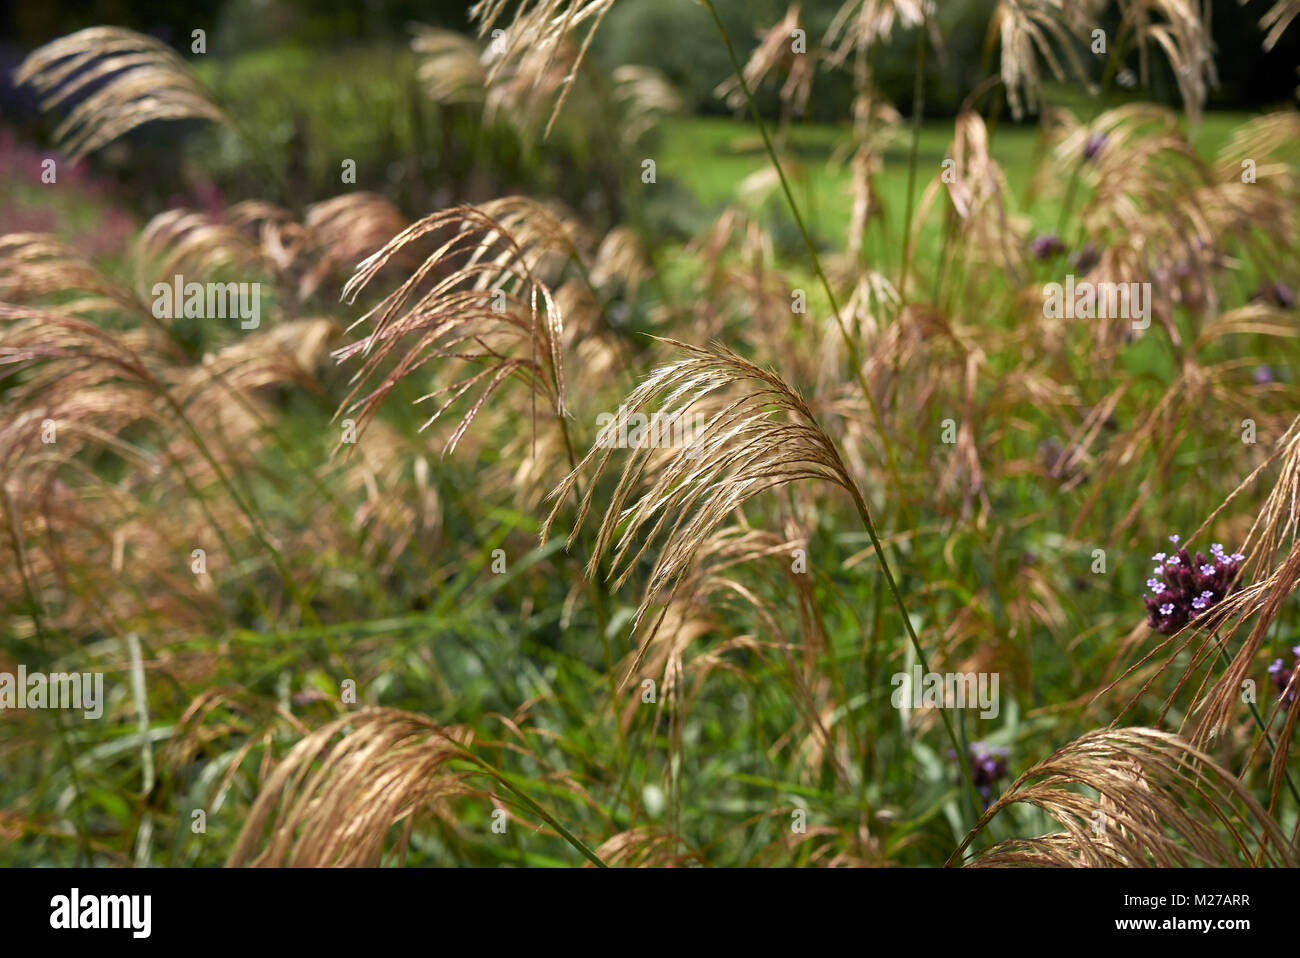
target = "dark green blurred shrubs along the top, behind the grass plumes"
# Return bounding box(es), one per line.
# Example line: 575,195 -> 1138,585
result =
0,0 -> 1300,222
